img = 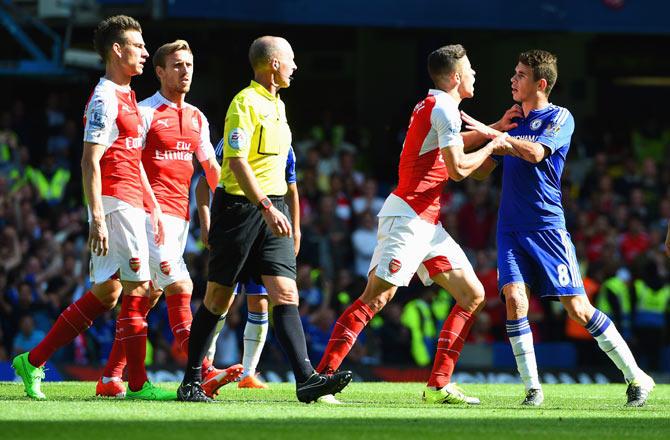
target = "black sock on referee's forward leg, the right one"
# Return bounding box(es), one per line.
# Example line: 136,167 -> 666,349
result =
272,304 -> 314,383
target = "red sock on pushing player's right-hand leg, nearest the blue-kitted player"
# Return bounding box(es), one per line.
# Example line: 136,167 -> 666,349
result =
428,304 -> 475,388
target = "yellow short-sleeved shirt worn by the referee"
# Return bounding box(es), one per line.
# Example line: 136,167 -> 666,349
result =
219,81 -> 291,196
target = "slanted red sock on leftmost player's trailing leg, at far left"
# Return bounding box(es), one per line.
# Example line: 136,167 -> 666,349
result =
28,291 -> 107,367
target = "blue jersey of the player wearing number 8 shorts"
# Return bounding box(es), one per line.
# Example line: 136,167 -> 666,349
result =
495,104 -> 575,232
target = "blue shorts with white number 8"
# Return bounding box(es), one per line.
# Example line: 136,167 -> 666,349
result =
498,229 -> 586,299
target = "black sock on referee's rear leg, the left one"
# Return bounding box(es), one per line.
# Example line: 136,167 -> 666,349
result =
184,304 -> 220,383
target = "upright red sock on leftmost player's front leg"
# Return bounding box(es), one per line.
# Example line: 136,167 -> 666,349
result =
117,295 -> 149,391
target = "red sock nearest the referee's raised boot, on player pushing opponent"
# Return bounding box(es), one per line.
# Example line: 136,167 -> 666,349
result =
316,299 -> 375,373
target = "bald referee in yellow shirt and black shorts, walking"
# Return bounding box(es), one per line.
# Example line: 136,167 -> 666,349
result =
177,36 -> 351,403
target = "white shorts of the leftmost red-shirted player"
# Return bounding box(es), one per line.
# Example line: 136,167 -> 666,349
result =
90,206 -> 150,283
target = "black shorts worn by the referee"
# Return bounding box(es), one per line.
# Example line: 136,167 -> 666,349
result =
208,188 -> 296,286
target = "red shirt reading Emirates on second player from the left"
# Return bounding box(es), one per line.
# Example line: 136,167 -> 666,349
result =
139,92 -> 214,221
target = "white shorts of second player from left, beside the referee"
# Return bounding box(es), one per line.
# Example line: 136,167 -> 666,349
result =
145,214 -> 191,290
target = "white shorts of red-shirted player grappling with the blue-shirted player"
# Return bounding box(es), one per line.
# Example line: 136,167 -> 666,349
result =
368,217 -> 471,286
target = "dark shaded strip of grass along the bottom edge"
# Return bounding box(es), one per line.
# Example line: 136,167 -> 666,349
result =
0,418 -> 670,440
